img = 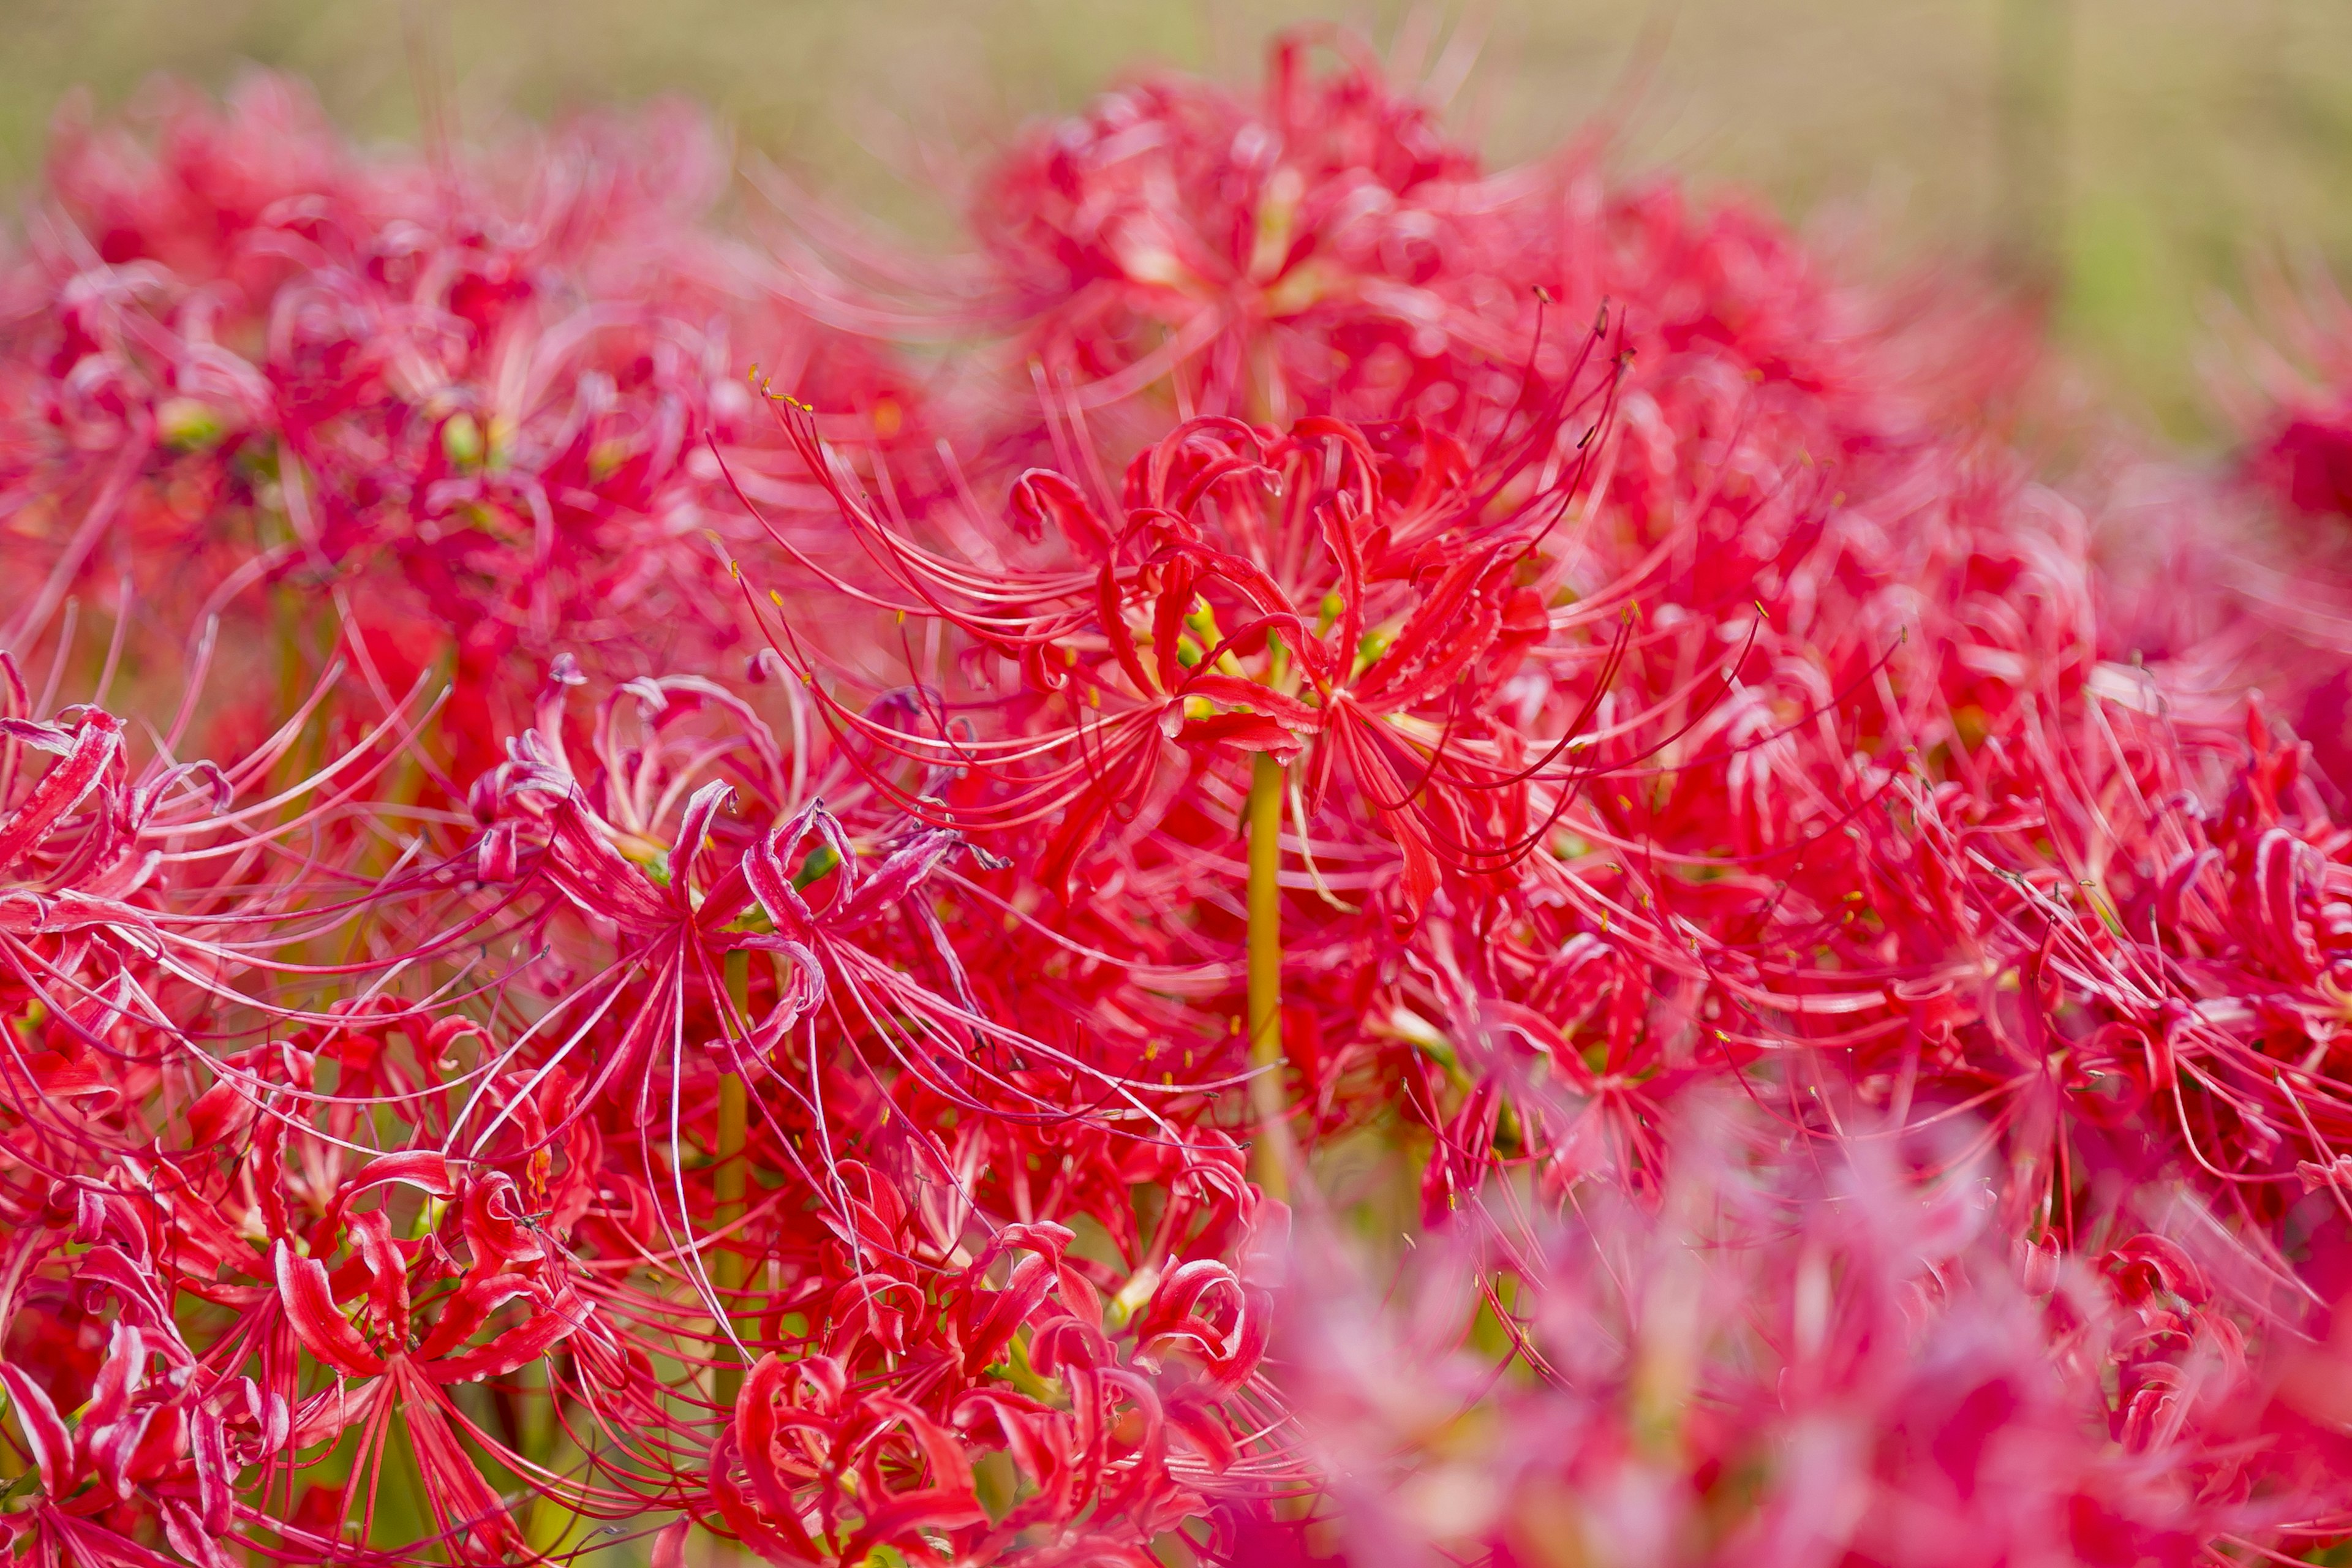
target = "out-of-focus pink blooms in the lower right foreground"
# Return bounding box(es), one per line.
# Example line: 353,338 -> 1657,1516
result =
1277,1105 -> 2343,1568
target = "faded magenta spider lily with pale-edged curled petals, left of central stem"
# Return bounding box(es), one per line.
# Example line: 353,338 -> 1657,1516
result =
461,677 -> 1213,1152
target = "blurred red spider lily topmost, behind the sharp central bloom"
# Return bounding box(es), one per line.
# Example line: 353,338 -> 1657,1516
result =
743,36 -> 1514,468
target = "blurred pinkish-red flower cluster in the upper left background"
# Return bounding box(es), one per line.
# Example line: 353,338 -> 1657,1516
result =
0,78 -> 905,774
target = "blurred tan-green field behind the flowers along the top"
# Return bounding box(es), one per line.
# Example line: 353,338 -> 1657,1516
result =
0,0 -> 2352,442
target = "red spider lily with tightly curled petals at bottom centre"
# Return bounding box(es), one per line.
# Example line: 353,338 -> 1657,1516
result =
668,1044 -> 1294,1563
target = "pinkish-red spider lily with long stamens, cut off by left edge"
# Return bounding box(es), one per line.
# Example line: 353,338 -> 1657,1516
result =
0,654 -> 486,1164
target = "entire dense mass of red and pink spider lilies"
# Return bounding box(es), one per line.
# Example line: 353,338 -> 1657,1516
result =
0,37 -> 2352,1568
